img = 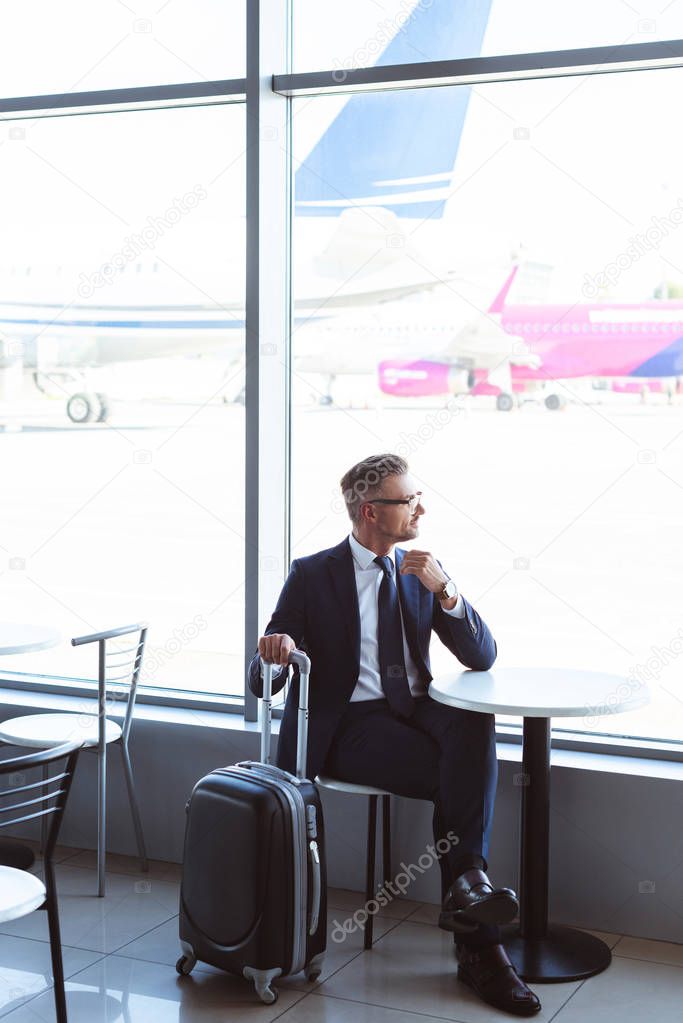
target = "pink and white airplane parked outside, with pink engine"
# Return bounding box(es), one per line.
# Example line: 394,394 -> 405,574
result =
378,265 -> 683,411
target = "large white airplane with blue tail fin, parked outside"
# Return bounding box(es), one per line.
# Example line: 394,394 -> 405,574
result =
0,0 -> 493,422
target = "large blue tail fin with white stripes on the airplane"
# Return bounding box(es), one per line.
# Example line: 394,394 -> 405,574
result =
295,0 -> 492,217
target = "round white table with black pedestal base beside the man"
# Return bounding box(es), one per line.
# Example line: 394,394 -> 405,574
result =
429,668 -> 649,983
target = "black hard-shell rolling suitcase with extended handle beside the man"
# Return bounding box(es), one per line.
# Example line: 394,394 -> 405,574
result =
176,651 -> 327,1005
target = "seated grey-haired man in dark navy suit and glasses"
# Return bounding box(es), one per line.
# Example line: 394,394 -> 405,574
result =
248,454 -> 541,1016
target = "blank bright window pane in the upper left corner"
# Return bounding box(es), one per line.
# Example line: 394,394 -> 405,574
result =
0,0 -> 245,96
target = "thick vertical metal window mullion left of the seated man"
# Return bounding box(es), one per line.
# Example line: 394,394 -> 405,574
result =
244,0 -> 289,721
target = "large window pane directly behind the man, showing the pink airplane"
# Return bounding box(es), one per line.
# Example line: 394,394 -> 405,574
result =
292,71 -> 683,740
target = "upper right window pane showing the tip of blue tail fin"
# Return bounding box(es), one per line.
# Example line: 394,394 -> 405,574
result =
293,0 -> 683,73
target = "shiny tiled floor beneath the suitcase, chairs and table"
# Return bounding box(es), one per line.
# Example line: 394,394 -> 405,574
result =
0,849 -> 683,1023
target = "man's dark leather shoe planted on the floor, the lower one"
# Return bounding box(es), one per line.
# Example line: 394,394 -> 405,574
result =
455,945 -> 541,1016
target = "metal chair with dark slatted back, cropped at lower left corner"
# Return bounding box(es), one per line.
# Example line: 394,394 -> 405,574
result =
0,743 -> 81,1023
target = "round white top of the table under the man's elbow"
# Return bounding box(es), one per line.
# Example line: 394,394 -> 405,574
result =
429,668 -> 649,717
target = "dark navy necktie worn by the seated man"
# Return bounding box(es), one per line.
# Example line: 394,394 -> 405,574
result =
375,554 -> 413,717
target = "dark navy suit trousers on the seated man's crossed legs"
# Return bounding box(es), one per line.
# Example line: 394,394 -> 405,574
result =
324,695 -> 500,946
